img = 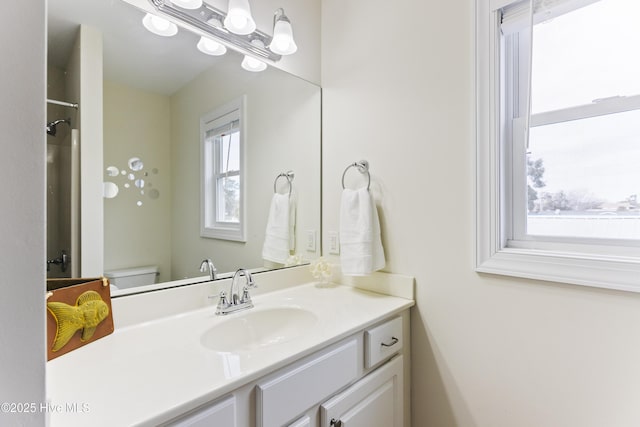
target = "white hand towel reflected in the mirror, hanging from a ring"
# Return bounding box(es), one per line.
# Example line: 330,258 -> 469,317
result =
262,193 -> 295,264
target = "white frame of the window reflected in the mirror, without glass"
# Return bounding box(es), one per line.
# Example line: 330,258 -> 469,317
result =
200,96 -> 247,242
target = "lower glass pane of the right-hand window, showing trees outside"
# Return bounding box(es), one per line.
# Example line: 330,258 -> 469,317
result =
527,110 -> 640,239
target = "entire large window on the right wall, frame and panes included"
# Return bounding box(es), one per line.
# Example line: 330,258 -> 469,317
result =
476,0 -> 640,291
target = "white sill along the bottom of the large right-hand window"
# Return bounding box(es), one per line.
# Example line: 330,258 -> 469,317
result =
476,248 -> 640,292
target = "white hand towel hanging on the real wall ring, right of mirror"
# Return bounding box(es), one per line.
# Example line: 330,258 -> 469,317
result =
340,188 -> 385,276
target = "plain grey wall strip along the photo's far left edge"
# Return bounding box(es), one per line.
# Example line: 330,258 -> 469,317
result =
0,0 -> 46,426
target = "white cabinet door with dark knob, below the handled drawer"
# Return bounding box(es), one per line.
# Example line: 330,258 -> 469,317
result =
320,355 -> 403,427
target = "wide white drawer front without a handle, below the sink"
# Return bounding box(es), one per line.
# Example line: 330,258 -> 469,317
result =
256,339 -> 362,427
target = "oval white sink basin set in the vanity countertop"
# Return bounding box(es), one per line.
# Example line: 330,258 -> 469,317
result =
200,307 -> 318,352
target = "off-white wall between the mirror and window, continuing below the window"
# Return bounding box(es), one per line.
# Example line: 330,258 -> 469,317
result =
322,0 -> 640,427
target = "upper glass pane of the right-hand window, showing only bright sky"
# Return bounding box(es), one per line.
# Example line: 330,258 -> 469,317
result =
531,0 -> 640,113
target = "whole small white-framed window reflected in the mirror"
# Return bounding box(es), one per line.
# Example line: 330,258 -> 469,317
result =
200,99 -> 246,242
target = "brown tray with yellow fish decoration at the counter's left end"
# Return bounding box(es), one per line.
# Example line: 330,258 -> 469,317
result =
47,277 -> 113,360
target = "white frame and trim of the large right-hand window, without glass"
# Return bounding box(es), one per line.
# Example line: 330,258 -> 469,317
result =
475,0 -> 640,292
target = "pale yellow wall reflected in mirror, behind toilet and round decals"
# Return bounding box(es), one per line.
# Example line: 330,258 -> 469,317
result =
102,81 -> 171,282
